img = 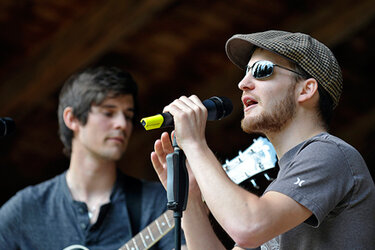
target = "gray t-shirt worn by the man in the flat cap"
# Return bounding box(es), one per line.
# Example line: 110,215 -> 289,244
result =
265,133 -> 375,250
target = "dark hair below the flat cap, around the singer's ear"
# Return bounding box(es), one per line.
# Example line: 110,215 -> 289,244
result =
292,63 -> 333,130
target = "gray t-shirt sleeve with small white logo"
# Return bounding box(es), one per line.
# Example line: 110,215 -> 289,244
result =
266,140 -> 354,227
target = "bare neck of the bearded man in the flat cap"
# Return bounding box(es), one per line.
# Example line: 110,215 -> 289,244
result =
266,112 -> 326,159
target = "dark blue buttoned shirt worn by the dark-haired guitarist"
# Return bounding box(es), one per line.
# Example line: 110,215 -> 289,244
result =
0,173 -> 184,250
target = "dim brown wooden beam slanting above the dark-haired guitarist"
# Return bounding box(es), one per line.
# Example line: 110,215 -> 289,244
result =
0,0 -> 172,118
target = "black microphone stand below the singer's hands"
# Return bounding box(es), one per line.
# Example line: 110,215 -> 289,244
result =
166,136 -> 189,250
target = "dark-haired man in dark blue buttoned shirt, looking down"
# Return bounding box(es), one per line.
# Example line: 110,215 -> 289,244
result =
0,67 -> 185,250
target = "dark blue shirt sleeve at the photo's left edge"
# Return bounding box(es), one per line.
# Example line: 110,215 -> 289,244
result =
0,193 -> 22,249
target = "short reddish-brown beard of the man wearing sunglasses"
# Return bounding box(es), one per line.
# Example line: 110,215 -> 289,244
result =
241,84 -> 296,134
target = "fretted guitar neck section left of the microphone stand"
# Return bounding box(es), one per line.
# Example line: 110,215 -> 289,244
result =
119,210 -> 174,250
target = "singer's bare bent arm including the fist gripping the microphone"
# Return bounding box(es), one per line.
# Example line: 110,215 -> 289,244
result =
160,96 -> 311,247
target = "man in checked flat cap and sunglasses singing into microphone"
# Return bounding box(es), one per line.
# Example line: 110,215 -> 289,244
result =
151,30 -> 375,250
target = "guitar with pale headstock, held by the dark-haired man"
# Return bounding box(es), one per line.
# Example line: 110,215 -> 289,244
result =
63,137 -> 277,250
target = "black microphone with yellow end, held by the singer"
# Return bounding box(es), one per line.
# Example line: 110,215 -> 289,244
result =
141,96 -> 233,130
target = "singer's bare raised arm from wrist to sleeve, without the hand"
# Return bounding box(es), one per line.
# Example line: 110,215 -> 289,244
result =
181,144 -> 311,248
